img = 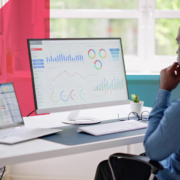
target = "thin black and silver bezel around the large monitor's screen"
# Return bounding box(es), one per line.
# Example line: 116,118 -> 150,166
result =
27,37 -> 130,114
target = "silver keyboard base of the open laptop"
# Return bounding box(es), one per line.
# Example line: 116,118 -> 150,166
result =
0,127 -> 62,144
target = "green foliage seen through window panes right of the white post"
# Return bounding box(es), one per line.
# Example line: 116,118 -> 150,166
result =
155,0 -> 180,55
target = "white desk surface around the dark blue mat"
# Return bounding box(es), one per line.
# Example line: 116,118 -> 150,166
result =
0,105 -> 151,167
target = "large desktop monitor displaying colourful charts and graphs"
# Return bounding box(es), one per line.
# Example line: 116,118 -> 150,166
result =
28,38 -> 129,124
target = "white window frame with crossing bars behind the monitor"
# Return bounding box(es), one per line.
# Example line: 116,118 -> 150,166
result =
50,0 -> 180,75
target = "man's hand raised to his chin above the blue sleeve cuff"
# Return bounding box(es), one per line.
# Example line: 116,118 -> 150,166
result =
160,62 -> 180,91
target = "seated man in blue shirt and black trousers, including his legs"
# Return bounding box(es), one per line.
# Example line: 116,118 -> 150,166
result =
95,28 -> 180,180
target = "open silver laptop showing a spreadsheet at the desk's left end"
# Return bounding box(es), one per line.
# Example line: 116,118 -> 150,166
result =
0,83 -> 62,144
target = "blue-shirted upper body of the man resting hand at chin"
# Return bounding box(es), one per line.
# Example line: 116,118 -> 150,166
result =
144,28 -> 180,180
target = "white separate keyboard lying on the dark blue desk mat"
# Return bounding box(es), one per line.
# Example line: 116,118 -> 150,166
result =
77,120 -> 148,136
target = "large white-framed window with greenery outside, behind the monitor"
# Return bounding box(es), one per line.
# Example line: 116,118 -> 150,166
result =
50,0 -> 180,74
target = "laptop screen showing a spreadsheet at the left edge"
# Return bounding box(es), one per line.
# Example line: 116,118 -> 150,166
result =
0,83 -> 23,128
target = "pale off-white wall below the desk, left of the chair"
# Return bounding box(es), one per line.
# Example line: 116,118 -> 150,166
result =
9,143 -> 144,180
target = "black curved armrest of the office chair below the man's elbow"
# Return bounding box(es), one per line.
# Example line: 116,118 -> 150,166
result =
108,153 -> 164,180
